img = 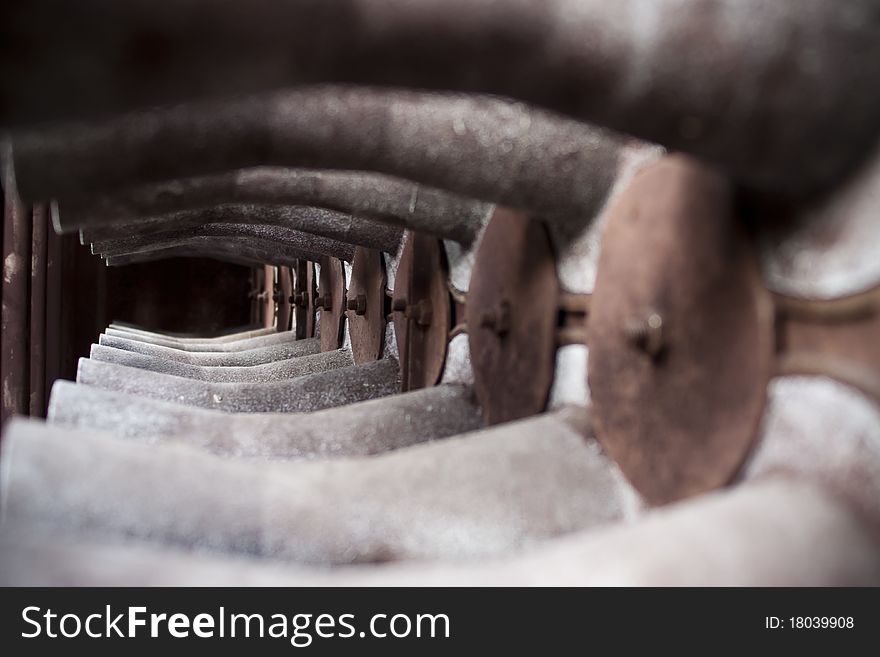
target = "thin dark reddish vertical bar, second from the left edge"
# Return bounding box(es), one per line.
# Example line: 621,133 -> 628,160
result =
30,204 -> 49,417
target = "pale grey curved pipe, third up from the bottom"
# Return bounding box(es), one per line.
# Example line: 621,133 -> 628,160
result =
49,382 -> 482,460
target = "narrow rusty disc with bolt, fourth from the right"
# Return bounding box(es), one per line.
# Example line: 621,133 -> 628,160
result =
345,247 -> 388,364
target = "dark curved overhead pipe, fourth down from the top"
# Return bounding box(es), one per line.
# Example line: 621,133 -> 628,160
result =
82,201 -> 403,257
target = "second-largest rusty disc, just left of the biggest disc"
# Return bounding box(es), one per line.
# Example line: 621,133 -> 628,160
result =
467,208 -> 559,424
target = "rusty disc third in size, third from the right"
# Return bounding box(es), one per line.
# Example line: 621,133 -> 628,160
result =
391,231 -> 452,392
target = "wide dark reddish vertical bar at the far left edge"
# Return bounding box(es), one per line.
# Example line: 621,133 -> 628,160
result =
0,161 -> 31,422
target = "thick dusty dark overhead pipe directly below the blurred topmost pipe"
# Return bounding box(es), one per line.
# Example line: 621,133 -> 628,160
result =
13,87 -> 620,220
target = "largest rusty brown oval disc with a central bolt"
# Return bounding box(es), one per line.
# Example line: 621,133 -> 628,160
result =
587,156 -> 774,504
